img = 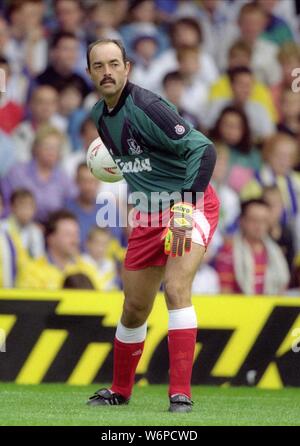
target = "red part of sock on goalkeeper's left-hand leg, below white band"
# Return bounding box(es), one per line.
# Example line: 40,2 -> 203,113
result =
111,338 -> 144,398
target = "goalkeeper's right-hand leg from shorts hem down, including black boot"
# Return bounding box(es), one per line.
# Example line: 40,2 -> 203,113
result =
165,243 -> 205,412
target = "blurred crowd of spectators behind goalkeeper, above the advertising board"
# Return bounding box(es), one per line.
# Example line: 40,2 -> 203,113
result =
0,0 -> 300,295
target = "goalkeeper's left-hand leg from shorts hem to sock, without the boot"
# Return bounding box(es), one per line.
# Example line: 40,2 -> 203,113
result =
111,267 -> 164,399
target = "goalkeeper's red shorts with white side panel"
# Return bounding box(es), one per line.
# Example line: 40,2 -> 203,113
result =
124,185 -> 220,271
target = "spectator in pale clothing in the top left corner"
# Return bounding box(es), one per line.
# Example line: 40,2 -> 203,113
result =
4,0 -> 48,77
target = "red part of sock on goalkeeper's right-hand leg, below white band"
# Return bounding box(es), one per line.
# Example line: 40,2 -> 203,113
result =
168,328 -> 197,398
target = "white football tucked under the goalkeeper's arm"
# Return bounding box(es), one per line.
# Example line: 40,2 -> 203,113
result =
86,137 -> 123,183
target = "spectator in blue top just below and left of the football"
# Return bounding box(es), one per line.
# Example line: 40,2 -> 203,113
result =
65,162 -> 123,251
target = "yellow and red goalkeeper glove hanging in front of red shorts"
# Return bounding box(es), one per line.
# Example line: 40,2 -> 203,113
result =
163,203 -> 194,257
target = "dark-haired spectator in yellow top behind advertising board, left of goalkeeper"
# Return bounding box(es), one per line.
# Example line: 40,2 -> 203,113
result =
16,211 -> 101,290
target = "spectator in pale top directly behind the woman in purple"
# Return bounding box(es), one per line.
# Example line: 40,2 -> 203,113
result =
12,85 -> 71,162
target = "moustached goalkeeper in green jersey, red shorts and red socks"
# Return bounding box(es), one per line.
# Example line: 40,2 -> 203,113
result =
87,39 -> 219,412
